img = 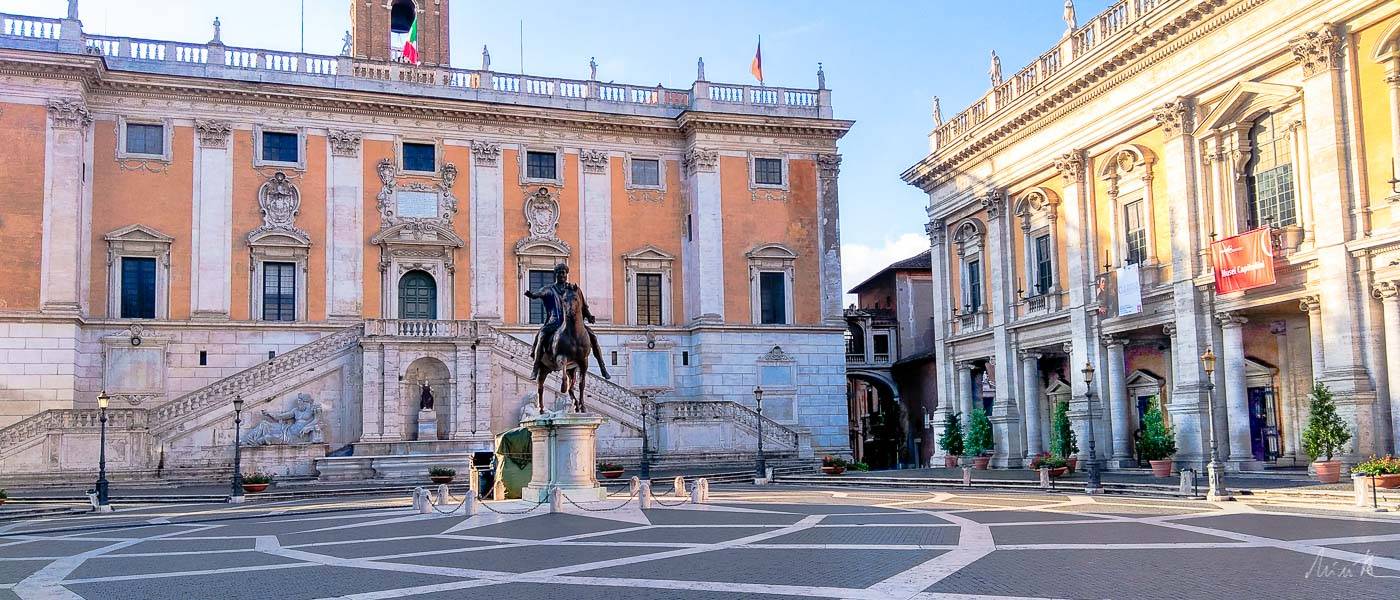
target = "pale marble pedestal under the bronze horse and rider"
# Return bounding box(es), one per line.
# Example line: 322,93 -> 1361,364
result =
521,413 -> 608,502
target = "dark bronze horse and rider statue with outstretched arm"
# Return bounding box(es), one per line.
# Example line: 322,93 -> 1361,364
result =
525,264 -> 612,413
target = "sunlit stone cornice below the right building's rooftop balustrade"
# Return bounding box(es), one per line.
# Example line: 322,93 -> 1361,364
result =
900,0 -> 1268,192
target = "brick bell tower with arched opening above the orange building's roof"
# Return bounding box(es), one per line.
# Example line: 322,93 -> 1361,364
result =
350,0 -> 449,67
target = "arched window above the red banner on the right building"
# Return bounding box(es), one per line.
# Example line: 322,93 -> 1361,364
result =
1245,112 -> 1298,228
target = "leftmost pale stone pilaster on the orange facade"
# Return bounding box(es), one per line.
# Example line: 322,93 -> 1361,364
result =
39,98 -> 92,316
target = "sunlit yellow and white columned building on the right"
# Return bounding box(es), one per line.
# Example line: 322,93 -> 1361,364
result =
903,0 -> 1400,470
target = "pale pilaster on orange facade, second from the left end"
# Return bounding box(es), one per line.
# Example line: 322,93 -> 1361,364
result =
189,120 -> 234,320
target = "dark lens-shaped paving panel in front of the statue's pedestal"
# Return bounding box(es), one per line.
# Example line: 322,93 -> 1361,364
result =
385,544 -> 665,573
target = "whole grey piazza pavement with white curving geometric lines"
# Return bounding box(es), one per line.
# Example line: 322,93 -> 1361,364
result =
0,487 -> 1400,600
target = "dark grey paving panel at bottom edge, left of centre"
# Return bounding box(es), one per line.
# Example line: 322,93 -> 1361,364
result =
66,566 -> 461,600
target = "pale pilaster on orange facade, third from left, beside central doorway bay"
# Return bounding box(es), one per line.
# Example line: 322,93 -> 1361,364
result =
326,130 -> 364,320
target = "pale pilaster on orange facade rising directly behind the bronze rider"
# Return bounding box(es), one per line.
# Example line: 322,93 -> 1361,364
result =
578,150 -> 613,323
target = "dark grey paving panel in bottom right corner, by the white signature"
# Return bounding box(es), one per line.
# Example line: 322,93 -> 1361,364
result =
928,548 -> 1400,600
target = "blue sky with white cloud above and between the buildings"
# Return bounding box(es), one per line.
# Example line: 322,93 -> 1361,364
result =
0,0 -> 1109,295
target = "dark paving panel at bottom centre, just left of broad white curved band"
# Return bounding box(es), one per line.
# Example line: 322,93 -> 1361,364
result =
577,548 -> 942,587
